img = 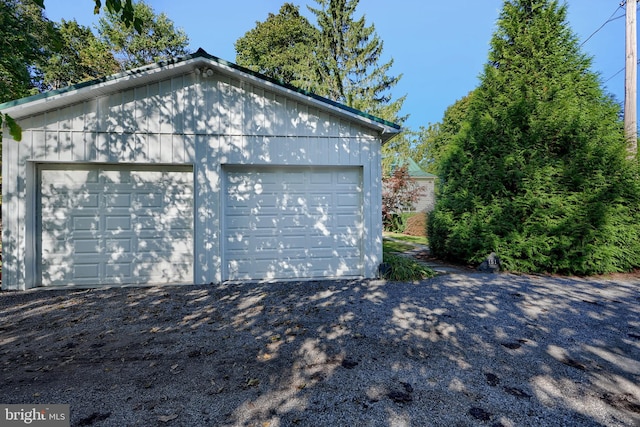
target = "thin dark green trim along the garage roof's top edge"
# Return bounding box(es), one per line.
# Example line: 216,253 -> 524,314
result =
0,48 -> 401,131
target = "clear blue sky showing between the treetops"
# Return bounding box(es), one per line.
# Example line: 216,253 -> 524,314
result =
45,0 -> 625,130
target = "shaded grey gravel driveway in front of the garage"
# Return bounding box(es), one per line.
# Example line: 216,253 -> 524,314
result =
0,272 -> 640,427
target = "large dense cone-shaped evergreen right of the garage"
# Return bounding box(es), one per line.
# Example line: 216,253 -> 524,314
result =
429,0 -> 640,274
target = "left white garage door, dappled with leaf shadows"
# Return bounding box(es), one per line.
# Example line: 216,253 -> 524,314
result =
39,165 -> 193,286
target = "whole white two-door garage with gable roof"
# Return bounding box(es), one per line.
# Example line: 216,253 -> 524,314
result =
0,50 -> 399,290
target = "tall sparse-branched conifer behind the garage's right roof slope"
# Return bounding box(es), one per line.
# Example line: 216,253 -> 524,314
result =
309,0 -> 405,122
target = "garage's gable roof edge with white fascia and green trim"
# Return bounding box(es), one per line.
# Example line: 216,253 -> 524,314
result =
0,48 -> 401,142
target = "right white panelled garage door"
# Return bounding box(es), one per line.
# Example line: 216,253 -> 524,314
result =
223,167 -> 363,280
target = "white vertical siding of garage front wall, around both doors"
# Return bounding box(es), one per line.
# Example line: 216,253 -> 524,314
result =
2,69 -> 382,289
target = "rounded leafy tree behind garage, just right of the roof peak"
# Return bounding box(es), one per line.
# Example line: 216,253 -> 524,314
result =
235,3 -> 318,91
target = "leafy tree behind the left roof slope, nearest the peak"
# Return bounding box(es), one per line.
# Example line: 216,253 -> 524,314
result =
98,2 -> 189,70
